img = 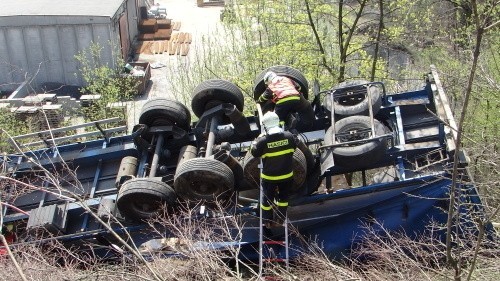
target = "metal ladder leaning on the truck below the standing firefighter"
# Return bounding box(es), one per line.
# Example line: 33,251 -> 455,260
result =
257,104 -> 290,280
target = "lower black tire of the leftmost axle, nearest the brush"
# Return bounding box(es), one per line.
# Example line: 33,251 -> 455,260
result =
116,178 -> 177,221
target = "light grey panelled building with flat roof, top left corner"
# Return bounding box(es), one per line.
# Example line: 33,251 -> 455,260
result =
0,0 -> 144,91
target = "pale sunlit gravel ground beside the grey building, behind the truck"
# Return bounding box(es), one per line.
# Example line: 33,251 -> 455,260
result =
127,0 -> 223,132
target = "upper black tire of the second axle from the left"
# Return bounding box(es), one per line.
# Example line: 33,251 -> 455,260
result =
191,79 -> 244,117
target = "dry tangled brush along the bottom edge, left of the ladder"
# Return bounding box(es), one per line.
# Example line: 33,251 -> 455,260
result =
0,200 -> 248,280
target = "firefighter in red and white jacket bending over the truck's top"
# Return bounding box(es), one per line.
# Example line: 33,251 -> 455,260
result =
258,71 -> 301,129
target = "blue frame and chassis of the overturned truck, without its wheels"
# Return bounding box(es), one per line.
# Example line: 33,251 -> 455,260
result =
0,64 -> 490,261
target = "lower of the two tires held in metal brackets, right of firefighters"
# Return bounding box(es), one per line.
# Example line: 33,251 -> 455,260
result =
325,115 -> 388,169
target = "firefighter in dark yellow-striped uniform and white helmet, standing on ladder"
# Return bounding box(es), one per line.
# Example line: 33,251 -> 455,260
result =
250,111 -> 299,228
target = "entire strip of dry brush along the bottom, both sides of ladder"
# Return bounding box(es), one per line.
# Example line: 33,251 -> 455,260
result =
0,199 -> 500,281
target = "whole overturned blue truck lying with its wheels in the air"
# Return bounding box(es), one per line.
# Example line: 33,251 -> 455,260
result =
0,66 -> 492,260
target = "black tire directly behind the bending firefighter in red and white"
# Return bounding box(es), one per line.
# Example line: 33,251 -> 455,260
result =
253,65 -> 309,100
